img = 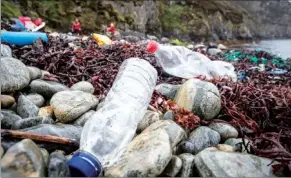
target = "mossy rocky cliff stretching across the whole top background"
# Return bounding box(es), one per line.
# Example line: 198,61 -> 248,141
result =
1,0 -> 291,41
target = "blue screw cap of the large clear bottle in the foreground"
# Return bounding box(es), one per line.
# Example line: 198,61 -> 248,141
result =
68,152 -> 103,177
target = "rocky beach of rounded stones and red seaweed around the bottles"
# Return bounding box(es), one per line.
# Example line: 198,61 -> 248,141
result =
0,33 -> 291,177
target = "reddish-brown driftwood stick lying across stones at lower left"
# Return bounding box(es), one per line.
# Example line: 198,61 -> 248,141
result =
1,129 -> 79,147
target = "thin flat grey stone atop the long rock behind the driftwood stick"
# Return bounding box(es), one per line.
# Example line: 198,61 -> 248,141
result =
11,116 -> 55,130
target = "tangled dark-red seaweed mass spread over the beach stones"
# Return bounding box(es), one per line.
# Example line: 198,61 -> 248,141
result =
9,38 -> 291,175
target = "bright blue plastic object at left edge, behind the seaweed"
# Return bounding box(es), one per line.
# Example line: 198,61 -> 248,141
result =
1,31 -> 48,46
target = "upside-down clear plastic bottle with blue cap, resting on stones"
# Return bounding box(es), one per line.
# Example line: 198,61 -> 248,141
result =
69,58 -> 157,177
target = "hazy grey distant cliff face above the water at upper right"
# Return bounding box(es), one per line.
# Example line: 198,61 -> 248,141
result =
233,0 -> 291,38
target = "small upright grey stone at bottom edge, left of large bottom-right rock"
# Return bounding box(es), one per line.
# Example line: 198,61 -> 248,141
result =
178,153 -> 195,177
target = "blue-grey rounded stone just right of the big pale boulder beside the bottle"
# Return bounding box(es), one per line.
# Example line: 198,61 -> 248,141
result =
180,126 -> 220,154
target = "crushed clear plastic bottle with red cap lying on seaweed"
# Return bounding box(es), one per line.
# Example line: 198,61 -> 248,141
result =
147,41 -> 237,81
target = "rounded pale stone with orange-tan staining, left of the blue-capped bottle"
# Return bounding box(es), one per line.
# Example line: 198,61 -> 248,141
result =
50,91 -> 98,123
